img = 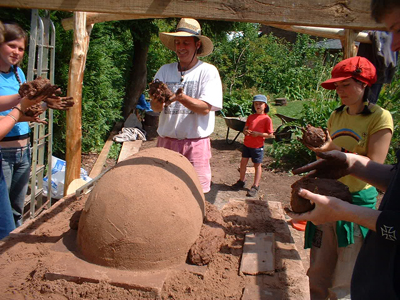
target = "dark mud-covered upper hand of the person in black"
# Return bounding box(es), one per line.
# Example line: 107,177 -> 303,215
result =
292,150 -> 351,179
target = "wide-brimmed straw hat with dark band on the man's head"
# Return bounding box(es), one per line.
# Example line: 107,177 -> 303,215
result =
159,18 -> 214,56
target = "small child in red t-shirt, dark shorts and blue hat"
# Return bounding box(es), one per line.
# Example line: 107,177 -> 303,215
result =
232,95 -> 274,197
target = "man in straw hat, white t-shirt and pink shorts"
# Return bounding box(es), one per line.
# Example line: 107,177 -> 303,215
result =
150,18 -> 222,193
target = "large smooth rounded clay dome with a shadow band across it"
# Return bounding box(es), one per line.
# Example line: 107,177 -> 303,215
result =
77,148 -> 205,271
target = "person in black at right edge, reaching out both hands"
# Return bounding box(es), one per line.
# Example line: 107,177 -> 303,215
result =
291,0 -> 400,300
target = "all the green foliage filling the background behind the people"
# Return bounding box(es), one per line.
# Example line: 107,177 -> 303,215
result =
0,8 -> 400,171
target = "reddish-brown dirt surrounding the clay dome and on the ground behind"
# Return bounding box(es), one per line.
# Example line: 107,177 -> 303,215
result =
0,119 -> 308,300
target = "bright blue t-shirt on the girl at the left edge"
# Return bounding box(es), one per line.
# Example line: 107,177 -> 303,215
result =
0,67 -> 30,137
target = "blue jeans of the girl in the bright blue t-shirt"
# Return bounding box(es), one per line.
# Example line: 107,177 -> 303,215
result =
1,145 -> 31,227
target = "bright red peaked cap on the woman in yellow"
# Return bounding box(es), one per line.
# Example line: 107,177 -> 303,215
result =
321,56 -> 377,90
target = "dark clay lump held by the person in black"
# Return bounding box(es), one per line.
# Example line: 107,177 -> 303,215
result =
290,177 -> 352,213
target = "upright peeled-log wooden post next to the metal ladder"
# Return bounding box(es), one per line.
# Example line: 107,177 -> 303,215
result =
64,12 -> 93,194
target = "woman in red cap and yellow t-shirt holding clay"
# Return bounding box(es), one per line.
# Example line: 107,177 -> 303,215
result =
305,56 -> 393,299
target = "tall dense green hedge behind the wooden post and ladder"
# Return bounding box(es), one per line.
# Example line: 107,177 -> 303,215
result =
52,12 -> 132,156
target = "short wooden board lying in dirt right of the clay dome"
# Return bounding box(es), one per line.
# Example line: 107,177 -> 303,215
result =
240,233 -> 275,275
